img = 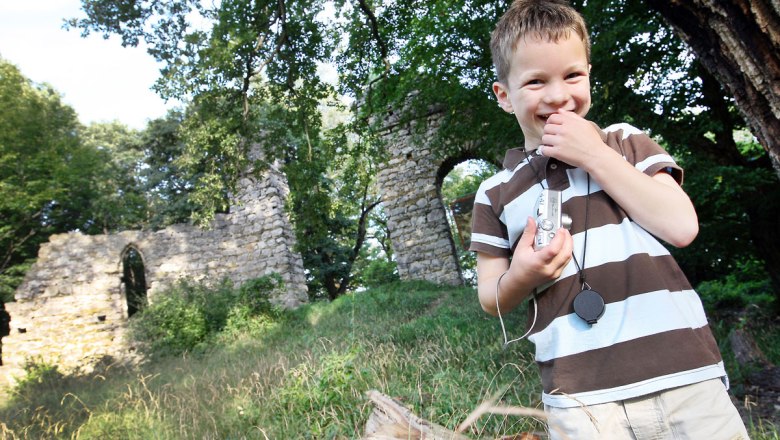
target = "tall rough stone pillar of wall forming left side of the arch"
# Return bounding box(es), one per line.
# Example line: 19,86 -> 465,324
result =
377,108 -> 463,285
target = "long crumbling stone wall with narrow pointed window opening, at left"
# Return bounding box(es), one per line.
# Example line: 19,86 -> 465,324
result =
0,162 -> 308,380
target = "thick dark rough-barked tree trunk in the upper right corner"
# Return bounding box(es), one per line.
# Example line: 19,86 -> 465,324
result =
648,0 -> 780,178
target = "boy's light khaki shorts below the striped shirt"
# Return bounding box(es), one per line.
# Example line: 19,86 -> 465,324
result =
545,379 -> 748,440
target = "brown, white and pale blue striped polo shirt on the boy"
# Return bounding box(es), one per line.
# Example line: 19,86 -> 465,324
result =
471,124 -> 726,408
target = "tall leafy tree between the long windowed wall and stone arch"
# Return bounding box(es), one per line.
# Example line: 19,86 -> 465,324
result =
69,0 -> 390,298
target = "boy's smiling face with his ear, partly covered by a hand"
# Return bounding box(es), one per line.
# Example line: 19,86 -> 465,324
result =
493,32 -> 590,150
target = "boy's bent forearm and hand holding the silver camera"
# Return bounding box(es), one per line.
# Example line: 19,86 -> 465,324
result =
477,217 -> 573,316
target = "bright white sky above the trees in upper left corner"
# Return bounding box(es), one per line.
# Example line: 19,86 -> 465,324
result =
0,0 -> 178,129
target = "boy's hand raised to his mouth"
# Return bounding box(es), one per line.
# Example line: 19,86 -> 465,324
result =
542,109 -> 609,171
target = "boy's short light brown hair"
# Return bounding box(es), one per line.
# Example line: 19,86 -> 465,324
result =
490,0 -> 590,83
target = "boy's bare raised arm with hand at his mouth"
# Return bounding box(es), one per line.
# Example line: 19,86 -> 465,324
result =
542,111 -> 699,247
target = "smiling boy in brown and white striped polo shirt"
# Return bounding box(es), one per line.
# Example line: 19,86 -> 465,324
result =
471,0 -> 747,440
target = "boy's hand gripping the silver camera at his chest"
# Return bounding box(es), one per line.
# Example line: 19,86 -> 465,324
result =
509,217 -> 574,289
